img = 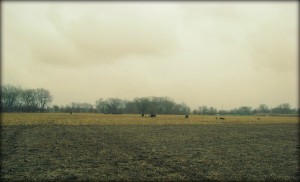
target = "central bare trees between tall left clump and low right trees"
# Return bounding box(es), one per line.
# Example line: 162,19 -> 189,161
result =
51,97 -> 190,114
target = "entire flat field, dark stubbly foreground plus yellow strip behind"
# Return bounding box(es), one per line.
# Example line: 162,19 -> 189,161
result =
1,113 -> 299,181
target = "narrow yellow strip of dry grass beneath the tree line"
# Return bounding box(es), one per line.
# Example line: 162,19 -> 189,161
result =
2,113 -> 299,125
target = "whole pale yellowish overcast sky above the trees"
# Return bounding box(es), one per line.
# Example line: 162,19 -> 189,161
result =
1,1 -> 299,109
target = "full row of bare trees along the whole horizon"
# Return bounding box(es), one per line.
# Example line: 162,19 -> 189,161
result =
0,85 -> 300,115
